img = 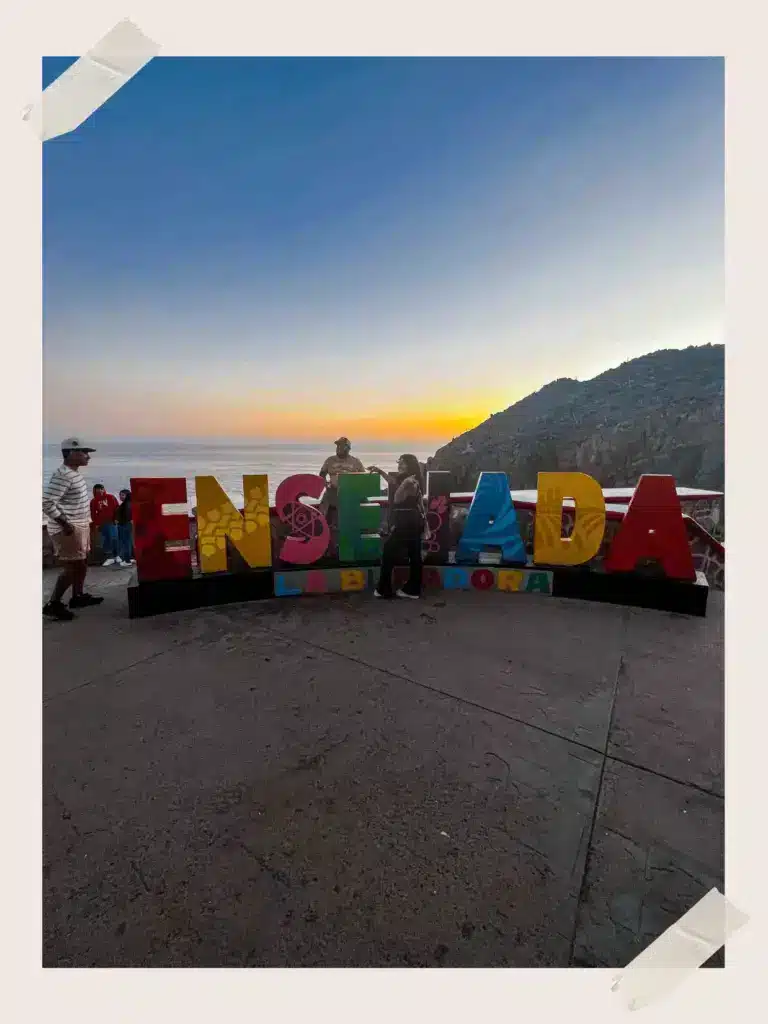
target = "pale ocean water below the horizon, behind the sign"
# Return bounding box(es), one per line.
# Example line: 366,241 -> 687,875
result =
43,438 -> 435,509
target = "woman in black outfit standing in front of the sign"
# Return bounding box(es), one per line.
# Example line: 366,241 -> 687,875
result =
369,455 -> 426,600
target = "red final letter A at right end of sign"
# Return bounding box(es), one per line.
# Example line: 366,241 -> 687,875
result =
605,474 -> 696,580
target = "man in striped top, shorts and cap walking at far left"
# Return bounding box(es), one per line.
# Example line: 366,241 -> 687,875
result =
43,437 -> 103,623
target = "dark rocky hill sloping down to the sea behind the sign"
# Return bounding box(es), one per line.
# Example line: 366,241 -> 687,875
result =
427,345 -> 725,490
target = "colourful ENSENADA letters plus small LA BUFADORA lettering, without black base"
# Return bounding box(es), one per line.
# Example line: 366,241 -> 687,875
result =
131,472 -> 696,596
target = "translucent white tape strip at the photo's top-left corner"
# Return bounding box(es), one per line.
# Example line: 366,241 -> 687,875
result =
23,18 -> 160,141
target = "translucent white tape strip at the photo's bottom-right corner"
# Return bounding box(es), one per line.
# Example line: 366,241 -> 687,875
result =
611,889 -> 750,1010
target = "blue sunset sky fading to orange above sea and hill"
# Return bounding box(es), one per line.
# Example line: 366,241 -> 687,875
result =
43,57 -> 724,444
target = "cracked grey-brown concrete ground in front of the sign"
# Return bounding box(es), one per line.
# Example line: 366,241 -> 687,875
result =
43,569 -> 724,967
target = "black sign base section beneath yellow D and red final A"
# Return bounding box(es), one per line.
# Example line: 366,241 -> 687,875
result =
552,568 -> 710,616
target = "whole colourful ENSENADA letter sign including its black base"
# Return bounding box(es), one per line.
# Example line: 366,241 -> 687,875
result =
129,472 -> 707,614
